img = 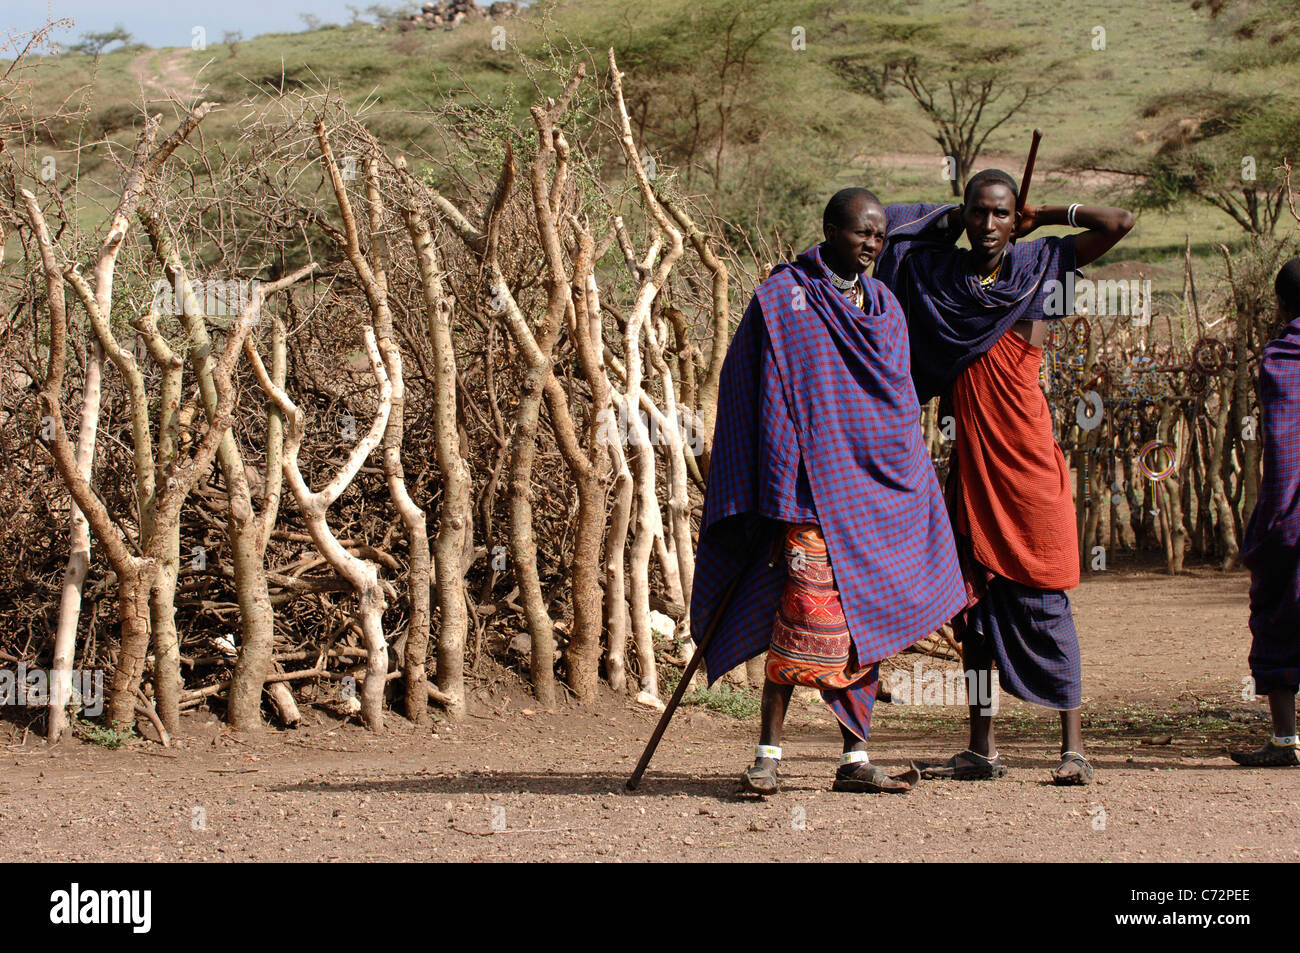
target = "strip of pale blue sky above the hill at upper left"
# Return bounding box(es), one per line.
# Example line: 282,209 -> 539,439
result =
10,0 -> 426,47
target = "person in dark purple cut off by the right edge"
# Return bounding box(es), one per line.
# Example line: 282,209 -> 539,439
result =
1232,259 -> 1300,767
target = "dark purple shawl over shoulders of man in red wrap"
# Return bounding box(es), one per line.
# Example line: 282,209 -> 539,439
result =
875,203 -> 1075,403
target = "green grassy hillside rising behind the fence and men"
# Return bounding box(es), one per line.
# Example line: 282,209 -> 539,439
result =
12,0 -> 1300,291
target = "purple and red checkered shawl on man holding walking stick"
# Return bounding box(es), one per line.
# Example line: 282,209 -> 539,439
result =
690,241 -> 965,683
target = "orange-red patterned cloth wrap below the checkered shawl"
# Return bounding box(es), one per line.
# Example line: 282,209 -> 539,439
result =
767,523 -> 872,689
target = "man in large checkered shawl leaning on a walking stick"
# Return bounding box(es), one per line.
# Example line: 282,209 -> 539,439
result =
690,189 -> 963,794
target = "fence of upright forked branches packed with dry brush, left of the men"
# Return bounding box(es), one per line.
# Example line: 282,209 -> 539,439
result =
0,44 -> 790,737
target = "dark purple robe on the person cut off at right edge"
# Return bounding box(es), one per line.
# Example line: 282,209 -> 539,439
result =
1242,312 -> 1300,693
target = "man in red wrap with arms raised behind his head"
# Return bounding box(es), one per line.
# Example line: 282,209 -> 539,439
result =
876,169 -> 1132,784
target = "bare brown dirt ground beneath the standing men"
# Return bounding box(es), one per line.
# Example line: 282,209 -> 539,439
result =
0,569 -> 1300,861
